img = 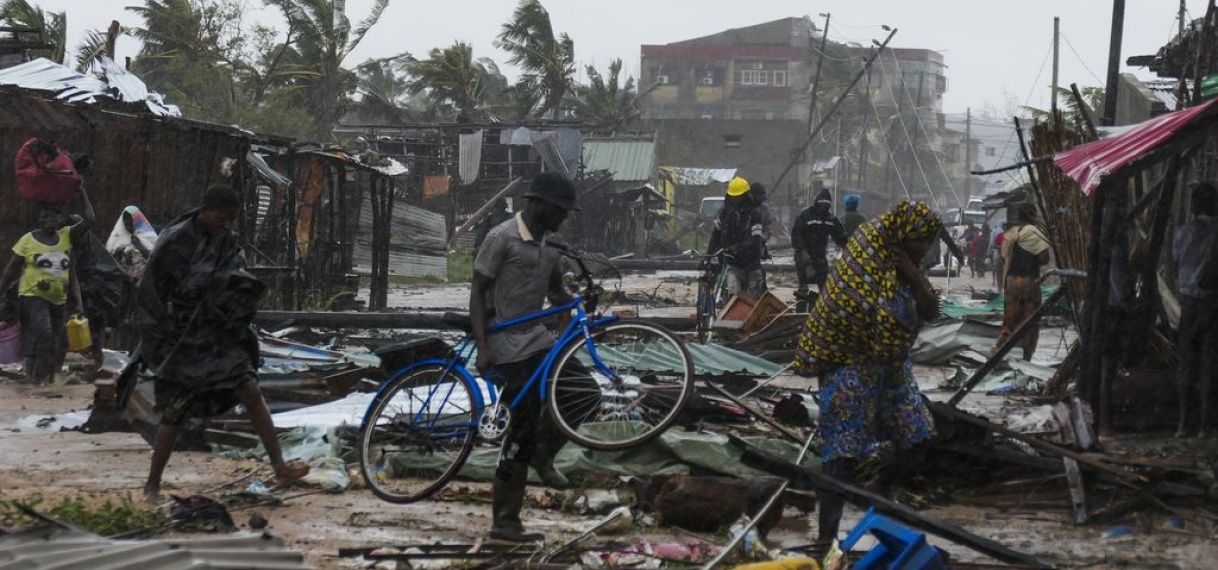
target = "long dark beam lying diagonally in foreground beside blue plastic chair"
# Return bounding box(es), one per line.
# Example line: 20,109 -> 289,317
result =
731,437 -> 1054,569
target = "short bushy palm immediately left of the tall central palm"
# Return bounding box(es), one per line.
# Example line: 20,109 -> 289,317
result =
403,41 -> 492,123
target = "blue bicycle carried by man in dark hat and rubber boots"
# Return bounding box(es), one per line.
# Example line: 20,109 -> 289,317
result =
359,252 -> 693,503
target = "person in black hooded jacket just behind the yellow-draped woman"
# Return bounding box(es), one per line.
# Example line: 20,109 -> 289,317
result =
790,189 -> 847,313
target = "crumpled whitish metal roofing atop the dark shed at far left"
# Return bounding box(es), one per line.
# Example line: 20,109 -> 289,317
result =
0,57 -> 181,117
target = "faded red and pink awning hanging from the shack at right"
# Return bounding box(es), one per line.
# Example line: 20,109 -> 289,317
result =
1054,99 -> 1218,196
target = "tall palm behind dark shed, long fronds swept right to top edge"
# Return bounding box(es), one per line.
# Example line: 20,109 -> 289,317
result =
264,0 -> 389,140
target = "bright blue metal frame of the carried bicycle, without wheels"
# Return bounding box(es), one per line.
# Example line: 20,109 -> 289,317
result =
378,295 -> 620,417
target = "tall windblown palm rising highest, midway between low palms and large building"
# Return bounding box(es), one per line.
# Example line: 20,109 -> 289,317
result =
495,0 -> 575,118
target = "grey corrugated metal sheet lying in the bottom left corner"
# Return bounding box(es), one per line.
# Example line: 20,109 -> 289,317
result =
0,526 -> 309,570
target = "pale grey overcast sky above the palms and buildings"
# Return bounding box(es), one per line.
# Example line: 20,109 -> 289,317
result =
30,0 -> 1206,112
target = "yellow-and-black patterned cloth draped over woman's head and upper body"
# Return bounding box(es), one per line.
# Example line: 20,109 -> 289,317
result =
795,202 -> 943,374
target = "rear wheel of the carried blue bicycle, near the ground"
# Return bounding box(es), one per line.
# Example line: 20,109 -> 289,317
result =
359,365 -> 477,503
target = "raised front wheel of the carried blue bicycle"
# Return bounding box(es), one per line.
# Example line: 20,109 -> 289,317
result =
548,323 -> 693,451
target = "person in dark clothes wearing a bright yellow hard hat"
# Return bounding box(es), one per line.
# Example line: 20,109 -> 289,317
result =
710,177 -> 766,300
